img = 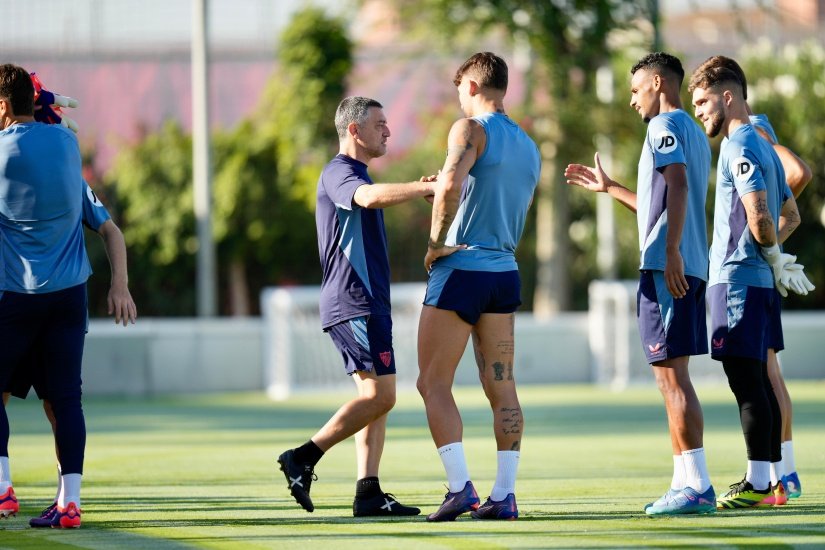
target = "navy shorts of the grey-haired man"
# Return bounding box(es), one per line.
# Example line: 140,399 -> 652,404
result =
324,315 -> 395,376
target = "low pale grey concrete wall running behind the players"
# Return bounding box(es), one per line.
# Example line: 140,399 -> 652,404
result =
83,283 -> 825,397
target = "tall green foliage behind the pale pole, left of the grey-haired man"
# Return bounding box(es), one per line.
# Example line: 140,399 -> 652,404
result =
100,9 -> 352,315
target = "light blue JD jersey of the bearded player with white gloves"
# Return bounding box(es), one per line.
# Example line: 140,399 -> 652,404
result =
708,124 -> 791,288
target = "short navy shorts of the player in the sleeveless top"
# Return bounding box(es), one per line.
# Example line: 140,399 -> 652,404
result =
424,264 -> 521,325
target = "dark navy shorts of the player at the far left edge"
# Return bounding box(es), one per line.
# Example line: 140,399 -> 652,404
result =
0,283 -> 88,401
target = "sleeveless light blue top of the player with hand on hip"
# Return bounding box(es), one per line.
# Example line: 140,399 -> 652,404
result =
436,113 -> 541,272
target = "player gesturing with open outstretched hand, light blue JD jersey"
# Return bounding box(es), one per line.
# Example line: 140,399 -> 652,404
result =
565,52 -> 715,515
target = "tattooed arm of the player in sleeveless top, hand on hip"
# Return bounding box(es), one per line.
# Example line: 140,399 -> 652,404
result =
424,118 -> 487,271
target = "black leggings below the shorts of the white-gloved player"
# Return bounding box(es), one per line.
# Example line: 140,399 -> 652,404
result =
722,357 -> 782,462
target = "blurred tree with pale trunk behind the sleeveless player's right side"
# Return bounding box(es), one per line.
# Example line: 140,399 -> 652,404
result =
376,0 -> 651,315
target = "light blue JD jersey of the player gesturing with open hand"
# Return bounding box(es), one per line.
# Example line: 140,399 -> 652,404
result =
636,109 -> 710,281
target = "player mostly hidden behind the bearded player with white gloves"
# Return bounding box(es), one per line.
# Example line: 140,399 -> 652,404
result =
702,55 -> 812,502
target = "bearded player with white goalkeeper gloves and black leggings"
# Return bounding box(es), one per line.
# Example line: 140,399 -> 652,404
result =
689,60 -> 810,509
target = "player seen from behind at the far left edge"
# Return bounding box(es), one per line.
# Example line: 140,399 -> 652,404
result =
0,65 -> 96,527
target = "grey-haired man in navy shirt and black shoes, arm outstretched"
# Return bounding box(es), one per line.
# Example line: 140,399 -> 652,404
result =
278,96 -> 435,516
